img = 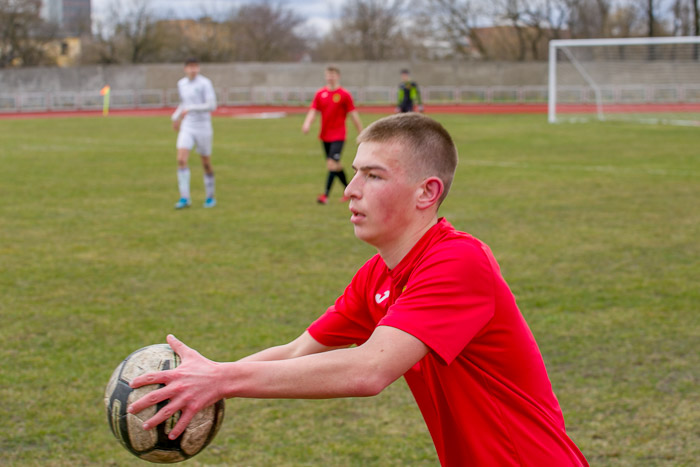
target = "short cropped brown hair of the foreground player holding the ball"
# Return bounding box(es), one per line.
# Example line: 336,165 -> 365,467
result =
357,112 -> 458,206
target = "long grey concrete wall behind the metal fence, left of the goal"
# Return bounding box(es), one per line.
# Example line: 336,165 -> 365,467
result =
0,62 -> 547,94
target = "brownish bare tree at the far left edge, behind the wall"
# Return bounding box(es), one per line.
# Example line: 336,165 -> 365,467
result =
0,0 -> 56,68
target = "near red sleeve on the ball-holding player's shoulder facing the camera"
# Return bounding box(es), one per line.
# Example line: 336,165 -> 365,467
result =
379,240 -> 500,364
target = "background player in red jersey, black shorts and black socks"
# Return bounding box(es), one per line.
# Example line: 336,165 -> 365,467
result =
301,66 -> 362,204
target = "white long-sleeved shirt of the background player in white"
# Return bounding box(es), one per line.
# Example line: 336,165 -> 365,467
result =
171,75 -> 216,132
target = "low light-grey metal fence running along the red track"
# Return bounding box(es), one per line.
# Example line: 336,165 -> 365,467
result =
0,85 -> 700,113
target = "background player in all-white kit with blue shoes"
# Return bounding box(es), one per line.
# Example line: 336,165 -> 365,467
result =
171,58 -> 216,209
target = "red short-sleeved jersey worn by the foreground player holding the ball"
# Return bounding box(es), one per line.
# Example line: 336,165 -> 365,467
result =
308,219 -> 588,467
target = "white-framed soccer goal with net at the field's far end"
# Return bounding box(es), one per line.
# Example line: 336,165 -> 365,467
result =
548,36 -> 700,126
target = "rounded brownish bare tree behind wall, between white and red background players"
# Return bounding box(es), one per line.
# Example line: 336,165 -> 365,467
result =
230,0 -> 306,62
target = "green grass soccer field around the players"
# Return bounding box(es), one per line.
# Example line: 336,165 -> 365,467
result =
0,111 -> 700,466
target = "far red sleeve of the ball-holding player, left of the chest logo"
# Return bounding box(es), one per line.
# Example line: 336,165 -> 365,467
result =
307,258 -> 376,347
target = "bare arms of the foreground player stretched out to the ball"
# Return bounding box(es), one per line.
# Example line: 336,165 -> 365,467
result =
129,326 -> 428,439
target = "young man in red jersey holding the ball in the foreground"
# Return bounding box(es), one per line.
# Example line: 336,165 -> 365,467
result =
129,113 -> 588,467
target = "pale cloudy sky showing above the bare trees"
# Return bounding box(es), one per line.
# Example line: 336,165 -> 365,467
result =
92,0 -> 343,34
